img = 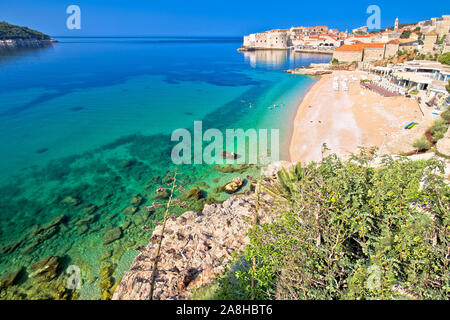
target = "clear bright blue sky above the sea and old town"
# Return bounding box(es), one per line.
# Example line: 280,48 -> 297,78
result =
0,0 -> 450,36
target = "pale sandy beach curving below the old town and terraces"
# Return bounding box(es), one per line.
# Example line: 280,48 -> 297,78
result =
289,71 -> 433,164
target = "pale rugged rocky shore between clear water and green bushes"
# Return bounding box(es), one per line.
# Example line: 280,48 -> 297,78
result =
113,162 -> 292,300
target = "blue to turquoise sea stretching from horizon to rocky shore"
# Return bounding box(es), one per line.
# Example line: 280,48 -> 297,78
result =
0,38 -> 330,299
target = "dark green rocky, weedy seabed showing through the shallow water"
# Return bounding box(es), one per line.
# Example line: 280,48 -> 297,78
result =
0,124 -> 256,299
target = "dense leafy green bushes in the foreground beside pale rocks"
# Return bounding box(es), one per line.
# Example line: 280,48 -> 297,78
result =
216,154 -> 450,299
